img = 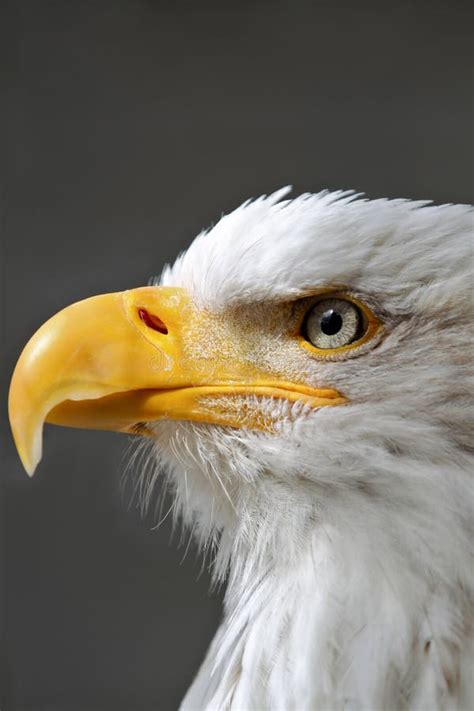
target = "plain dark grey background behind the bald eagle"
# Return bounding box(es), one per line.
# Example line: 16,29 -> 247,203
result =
0,0 -> 472,711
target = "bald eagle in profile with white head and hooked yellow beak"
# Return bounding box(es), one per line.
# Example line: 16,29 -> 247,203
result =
9,188 -> 474,711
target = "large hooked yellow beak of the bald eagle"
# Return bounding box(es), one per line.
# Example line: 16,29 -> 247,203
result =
9,287 -> 345,475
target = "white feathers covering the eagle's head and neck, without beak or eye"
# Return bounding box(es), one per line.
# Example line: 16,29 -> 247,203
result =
149,189 -> 474,711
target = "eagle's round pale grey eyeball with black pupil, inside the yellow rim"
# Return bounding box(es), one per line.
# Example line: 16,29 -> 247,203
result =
303,298 -> 367,350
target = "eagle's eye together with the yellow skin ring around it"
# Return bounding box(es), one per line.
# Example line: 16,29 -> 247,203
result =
298,292 -> 382,359
